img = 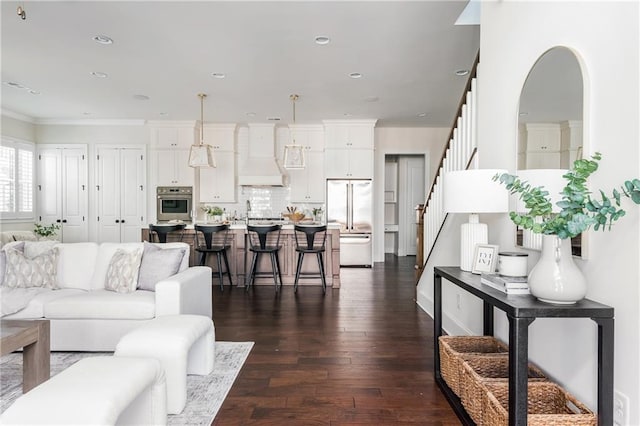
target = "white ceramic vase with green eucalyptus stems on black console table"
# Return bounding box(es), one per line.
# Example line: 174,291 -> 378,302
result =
494,152 -> 640,304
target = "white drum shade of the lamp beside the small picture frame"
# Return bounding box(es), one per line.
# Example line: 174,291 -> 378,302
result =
443,169 -> 509,213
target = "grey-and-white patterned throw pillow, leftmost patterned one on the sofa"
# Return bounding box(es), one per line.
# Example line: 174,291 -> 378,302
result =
3,248 -> 58,289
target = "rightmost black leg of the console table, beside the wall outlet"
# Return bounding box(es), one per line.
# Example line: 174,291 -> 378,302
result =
592,318 -> 614,426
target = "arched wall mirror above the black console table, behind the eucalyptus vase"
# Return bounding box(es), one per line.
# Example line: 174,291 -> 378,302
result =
516,47 -> 586,257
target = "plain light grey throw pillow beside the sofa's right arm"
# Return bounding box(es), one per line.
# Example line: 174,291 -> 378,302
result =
138,241 -> 186,291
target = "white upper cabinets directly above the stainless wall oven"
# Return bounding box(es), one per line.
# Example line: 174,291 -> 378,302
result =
149,121 -> 197,186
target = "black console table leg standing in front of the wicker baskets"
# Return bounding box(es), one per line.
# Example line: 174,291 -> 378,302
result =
508,316 -> 535,426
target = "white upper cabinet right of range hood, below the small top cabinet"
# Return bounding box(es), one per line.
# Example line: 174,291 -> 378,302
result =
289,151 -> 325,203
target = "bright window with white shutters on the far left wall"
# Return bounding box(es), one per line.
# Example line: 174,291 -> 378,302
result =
0,138 -> 35,219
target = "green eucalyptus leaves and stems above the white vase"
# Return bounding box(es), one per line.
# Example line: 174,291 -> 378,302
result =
493,152 -> 640,239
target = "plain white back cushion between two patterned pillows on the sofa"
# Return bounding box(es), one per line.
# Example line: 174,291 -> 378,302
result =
56,243 -> 98,290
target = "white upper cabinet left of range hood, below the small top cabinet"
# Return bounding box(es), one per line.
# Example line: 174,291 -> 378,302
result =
199,151 -> 236,203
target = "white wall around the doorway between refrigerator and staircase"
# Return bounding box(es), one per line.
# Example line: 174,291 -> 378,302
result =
373,127 -> 451,262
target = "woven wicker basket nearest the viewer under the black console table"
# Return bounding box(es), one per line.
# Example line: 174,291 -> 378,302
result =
483,382 -> 596,426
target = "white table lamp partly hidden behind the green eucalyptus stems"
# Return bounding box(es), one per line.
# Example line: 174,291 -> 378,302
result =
513,169 -> 569,250
